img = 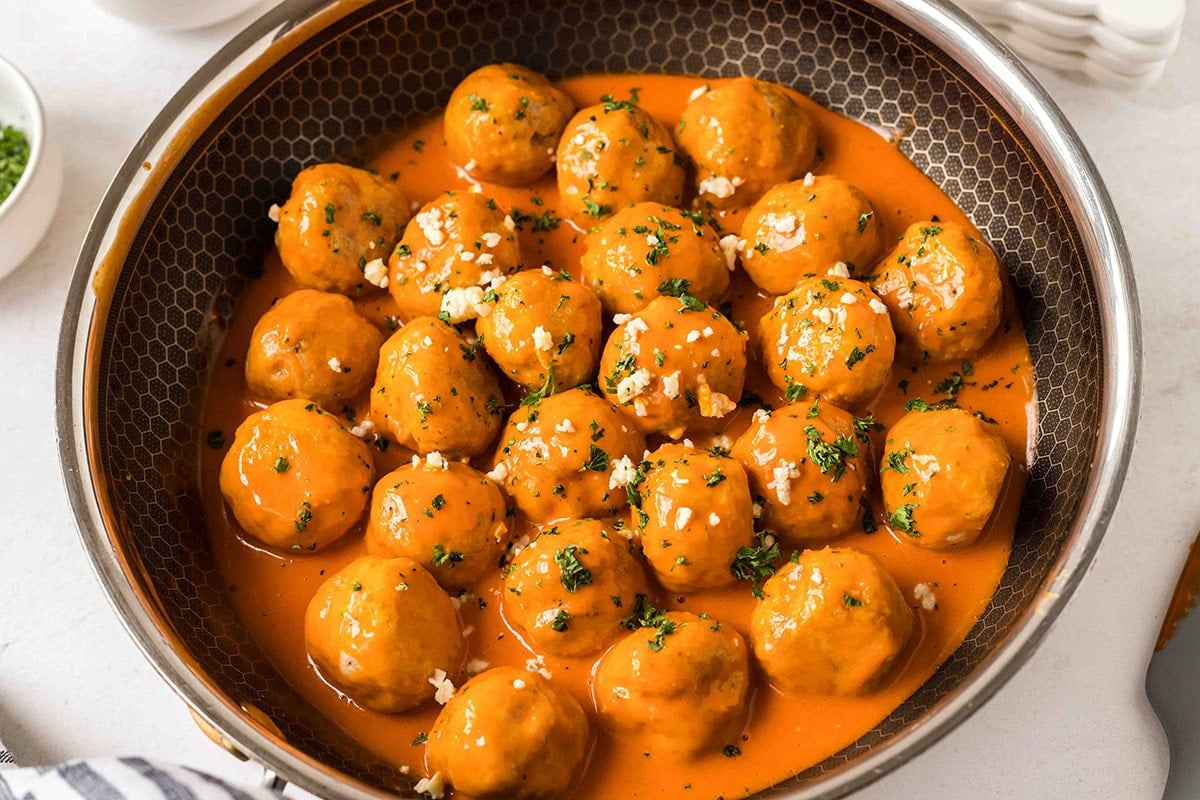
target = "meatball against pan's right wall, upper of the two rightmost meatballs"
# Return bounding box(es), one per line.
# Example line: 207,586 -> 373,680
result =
871,222 -> 1003,363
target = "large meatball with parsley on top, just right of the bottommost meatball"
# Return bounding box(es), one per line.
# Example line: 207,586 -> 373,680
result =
595,609 -> 750,759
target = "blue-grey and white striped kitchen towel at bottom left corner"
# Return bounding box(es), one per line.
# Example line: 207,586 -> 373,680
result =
0,742 -> 281,800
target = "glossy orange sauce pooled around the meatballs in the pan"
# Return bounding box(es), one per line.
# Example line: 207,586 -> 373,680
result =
200,76 -> 1034,800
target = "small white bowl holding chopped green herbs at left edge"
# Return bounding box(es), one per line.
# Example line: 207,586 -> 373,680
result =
0,59 -> 62,278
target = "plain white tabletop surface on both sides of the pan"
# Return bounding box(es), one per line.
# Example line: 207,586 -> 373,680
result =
0,0 -> 1200,800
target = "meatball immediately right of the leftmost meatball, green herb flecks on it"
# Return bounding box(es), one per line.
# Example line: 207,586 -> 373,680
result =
366,457 -> 509,589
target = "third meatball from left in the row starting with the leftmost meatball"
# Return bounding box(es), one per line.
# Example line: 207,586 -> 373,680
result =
490,389 -> 646,523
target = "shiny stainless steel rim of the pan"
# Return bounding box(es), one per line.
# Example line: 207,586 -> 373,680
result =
55,0 -> 1141,800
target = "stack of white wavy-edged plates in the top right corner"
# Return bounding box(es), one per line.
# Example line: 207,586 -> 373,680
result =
955,0 -> 1186,89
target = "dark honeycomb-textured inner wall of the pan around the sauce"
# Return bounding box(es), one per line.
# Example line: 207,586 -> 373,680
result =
97,0 -> 1102,796
